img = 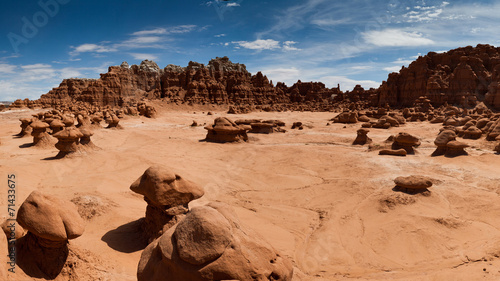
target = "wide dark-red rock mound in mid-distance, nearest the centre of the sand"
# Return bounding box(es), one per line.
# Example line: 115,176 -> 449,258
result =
205,117 -> 251,142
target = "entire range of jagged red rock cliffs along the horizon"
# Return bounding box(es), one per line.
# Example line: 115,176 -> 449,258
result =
11,45 -> 500,111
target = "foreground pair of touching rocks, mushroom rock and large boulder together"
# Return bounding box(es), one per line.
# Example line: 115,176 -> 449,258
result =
130,166 -> 293,281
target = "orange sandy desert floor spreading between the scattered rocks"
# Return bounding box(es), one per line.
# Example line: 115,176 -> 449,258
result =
0,105 -> 500,280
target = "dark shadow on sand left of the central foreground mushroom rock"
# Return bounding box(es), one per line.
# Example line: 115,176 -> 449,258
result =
101,218 -> 148,253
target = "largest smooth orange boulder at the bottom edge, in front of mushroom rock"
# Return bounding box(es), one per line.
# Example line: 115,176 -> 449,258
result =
137,203 -> 293,281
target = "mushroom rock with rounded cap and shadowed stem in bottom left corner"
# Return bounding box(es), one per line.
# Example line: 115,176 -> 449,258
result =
17,191 -> 85,279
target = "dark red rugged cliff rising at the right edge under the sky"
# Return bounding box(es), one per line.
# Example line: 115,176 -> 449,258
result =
375,45 -> 500,109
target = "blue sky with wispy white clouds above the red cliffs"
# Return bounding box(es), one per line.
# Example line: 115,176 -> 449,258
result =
0,0 -> 500,100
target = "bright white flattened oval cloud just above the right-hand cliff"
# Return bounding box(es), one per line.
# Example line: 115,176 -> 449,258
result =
362,29 -> 435,47
